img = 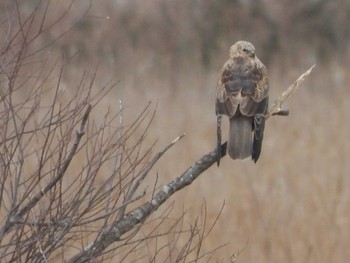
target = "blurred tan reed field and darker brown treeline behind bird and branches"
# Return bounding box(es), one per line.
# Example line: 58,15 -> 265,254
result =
0,0 -> 350,262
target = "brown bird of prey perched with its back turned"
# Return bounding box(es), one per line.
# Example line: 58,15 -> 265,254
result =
215,41 -> 269,165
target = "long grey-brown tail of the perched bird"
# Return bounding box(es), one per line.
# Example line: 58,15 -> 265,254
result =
227,115 -> 253,159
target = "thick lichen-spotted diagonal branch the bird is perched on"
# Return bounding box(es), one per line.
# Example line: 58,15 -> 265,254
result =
67,66 -> 314,263
